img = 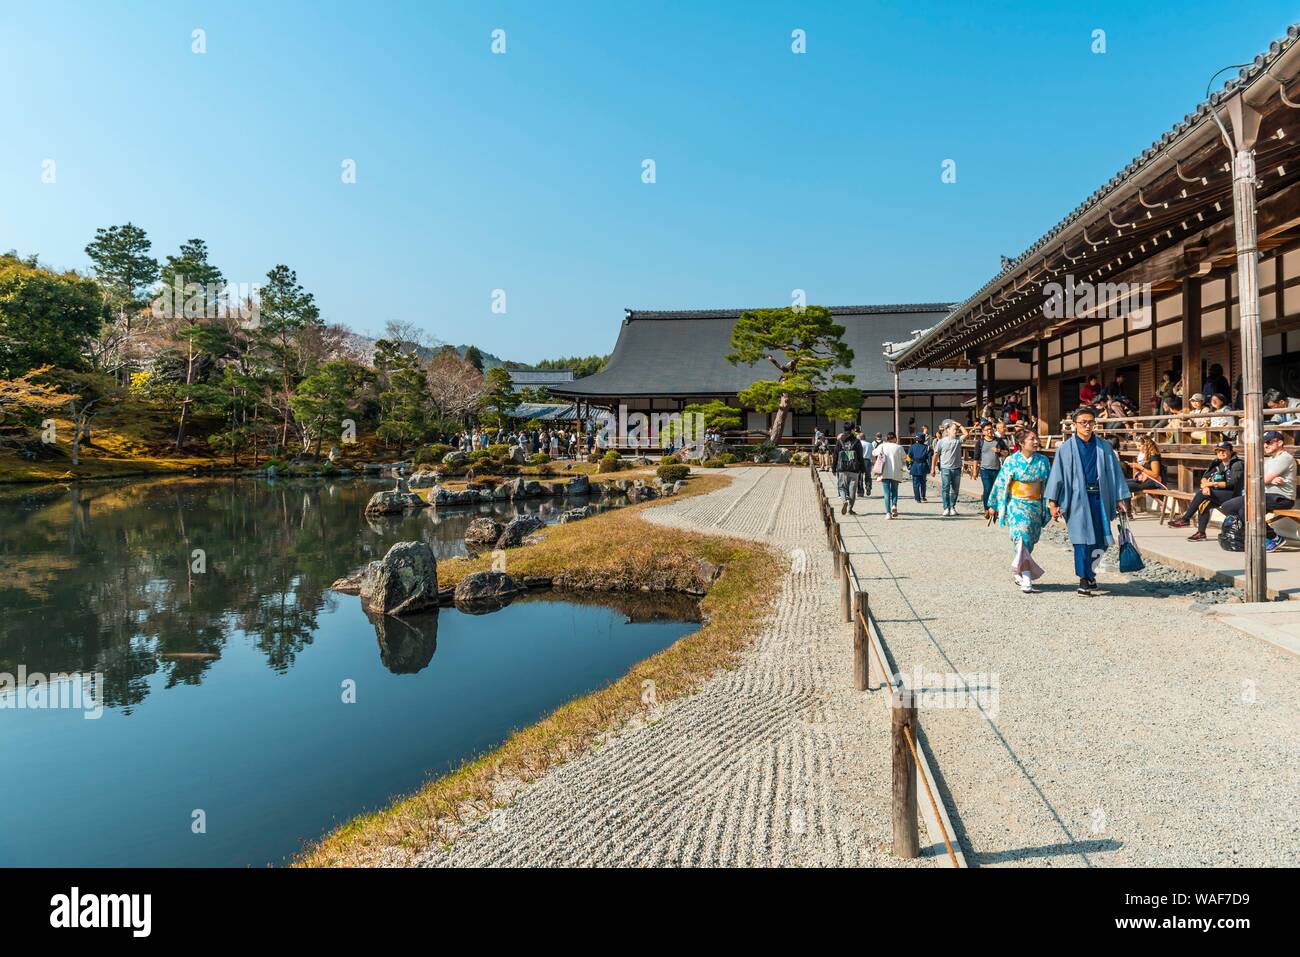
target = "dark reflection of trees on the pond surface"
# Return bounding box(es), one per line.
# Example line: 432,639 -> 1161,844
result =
0,477 -> 621,713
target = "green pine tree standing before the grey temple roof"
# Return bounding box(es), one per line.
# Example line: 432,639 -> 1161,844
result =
727,306 -> 862,445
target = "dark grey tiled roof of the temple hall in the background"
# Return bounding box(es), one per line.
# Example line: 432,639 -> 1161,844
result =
551,303 -> 975,397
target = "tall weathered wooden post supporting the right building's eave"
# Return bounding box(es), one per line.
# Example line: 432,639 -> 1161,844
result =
1232,136 -> 1268,602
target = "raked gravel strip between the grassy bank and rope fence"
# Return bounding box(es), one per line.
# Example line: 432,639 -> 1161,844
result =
420,468 -> 943,866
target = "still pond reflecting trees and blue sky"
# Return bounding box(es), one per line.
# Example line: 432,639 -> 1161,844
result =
0,479 -> 698,866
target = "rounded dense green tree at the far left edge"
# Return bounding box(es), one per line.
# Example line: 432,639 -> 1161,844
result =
0,252 -> 104,378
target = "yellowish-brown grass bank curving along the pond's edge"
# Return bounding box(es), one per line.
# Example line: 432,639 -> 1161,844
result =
295,473 -> 783,867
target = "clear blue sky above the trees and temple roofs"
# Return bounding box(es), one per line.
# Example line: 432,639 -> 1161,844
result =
0,0 -> 1300,361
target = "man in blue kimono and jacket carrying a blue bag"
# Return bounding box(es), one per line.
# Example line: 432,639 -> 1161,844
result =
1043,406 -> 1131,596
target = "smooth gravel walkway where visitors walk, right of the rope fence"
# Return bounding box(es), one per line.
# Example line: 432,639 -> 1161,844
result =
832,476 -> 1300,866
